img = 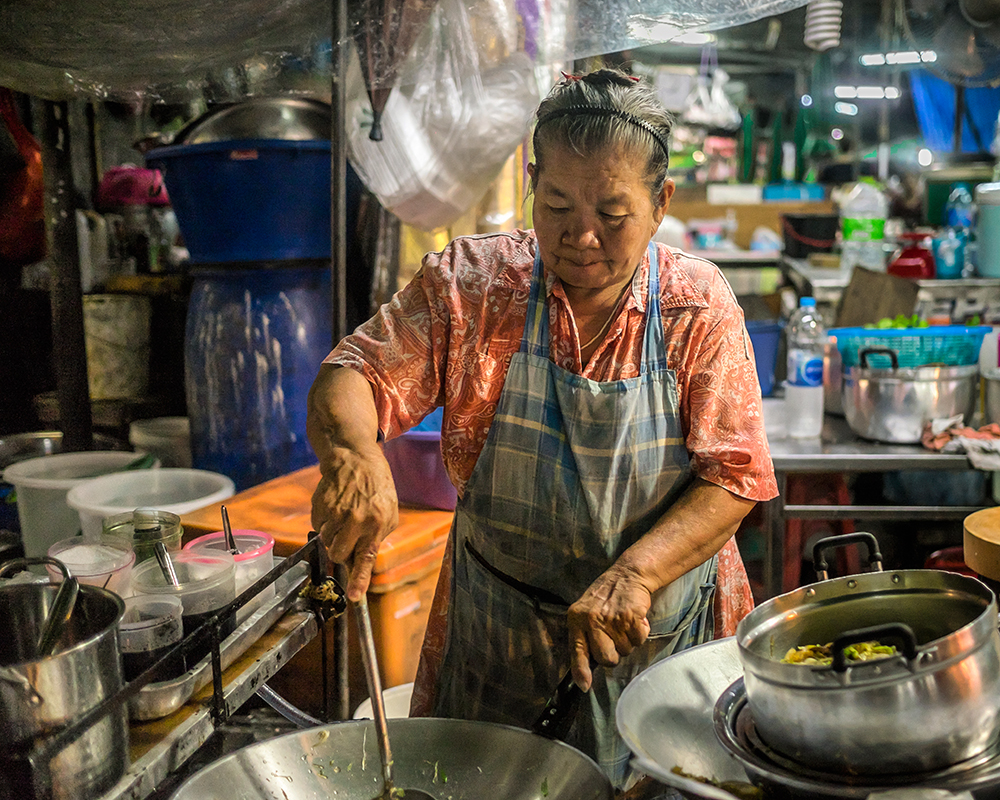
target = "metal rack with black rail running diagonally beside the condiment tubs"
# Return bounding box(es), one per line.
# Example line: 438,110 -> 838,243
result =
0,533 -> 347,800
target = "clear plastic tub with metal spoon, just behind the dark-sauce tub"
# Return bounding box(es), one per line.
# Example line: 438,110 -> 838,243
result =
132,550 -> 236,668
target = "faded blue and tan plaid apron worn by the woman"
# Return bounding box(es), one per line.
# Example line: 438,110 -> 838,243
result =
433,243 -> 717,787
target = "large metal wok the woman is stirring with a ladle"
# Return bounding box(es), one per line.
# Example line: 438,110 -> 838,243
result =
172,718 -> 612,800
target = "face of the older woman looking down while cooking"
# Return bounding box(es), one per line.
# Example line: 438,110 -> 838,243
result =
528,146 -> 674,293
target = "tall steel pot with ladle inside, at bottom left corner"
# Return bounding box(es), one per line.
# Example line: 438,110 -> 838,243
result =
0,559 -> 129,800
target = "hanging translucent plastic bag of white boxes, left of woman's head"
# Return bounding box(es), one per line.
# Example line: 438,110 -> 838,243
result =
347,0 -> 539,231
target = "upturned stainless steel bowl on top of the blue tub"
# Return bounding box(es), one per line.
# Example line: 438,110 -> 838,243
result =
173,97 -> 330,144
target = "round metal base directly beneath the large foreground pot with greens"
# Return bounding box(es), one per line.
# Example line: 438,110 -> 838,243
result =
714,678 -> 1000,800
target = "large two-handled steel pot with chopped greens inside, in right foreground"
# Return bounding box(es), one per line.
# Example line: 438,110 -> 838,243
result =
736,534 -> 1000,774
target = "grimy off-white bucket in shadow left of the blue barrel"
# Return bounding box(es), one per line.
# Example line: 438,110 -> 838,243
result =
83,294 -> 151,400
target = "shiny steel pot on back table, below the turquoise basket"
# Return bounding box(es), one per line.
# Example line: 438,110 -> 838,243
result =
843,348 -> 979,444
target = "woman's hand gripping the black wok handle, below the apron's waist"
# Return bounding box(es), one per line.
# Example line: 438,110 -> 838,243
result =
568,564 -> 652,691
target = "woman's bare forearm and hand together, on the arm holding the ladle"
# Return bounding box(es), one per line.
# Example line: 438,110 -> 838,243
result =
306,364 -> 399,601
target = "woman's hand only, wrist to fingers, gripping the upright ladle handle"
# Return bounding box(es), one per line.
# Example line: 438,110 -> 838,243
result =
312,445 -> 399,600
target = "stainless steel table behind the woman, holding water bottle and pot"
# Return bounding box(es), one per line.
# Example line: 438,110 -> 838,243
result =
763,397 -> 982,597
